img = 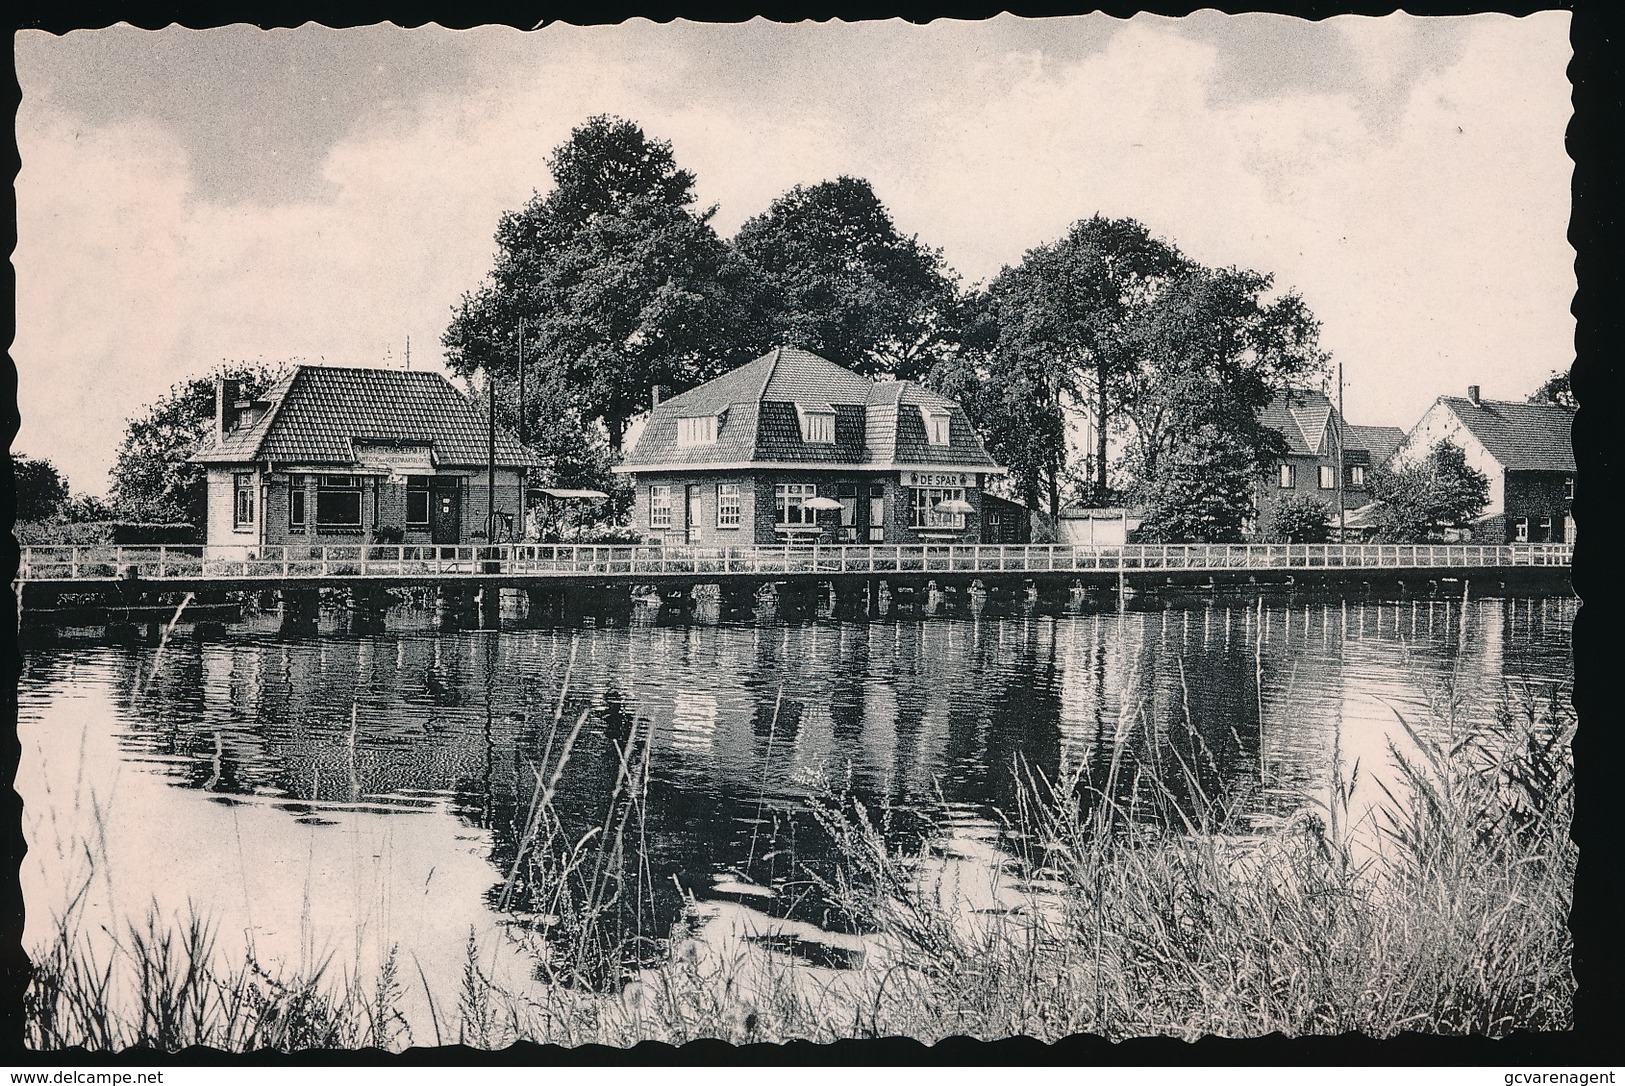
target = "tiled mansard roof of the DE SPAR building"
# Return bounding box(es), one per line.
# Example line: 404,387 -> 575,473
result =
624,348 -> 998,470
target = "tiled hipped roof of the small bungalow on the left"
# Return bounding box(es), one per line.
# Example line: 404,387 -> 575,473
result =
192,366 -> 540,467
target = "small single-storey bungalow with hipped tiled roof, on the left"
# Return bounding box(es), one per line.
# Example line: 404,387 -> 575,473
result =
192,366 -> 540,546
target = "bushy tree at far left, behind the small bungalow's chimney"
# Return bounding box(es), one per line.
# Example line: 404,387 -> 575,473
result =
109,363 -> 280,525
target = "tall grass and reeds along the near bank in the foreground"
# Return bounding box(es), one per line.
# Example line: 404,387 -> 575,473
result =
24,683 -> 1576,1050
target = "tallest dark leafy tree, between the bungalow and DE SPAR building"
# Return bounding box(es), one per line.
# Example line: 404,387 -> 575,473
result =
444,117 -> 744,455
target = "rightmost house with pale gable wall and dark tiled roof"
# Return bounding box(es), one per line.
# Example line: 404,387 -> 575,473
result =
1394,385 -> 1575,543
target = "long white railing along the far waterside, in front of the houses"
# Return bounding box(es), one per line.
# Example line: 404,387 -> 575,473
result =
18,543 -> 1575,582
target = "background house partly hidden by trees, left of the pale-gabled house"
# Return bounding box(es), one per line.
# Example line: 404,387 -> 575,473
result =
1255,389 -> 1406,525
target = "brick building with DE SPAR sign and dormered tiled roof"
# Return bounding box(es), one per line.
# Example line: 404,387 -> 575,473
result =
616,348 -> 1006,546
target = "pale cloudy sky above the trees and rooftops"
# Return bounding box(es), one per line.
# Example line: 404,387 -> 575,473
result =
11,11 -> 1575,494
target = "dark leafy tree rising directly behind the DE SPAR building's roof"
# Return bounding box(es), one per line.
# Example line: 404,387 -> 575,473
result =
733,177 -> 959,379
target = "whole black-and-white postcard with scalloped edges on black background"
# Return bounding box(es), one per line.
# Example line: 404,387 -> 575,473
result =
11,11 -> 1586,1052
